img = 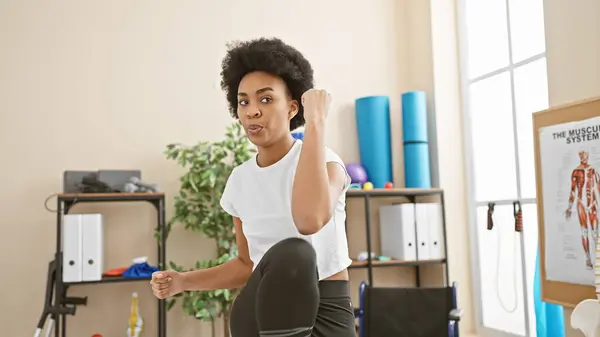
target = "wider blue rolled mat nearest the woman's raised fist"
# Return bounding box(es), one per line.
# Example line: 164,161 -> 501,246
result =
356,96 -> 392,188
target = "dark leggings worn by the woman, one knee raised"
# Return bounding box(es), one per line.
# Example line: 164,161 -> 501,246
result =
231,238 -> 356,337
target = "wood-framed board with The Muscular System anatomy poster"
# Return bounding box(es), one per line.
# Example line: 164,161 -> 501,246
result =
533,97 -> 600,307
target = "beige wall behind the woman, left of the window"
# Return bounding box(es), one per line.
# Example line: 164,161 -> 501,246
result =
0,0 -> 473,336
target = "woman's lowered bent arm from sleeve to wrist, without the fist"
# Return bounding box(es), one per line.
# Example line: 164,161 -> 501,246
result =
182,217 -> 253,291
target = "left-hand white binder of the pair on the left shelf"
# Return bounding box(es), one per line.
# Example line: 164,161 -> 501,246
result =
62,214 -> 82,282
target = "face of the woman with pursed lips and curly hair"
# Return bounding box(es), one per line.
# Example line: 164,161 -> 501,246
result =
237,71 -> 299,147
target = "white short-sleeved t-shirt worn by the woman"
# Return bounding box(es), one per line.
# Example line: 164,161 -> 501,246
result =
221,140 -> 352,280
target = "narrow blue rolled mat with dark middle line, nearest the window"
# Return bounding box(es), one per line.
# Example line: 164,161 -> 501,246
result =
402,91 -> 431,188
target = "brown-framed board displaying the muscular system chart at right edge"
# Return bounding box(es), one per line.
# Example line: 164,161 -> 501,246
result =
533,97 -> 600,307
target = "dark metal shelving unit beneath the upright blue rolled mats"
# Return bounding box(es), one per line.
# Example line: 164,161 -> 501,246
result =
346,188 -> 450,287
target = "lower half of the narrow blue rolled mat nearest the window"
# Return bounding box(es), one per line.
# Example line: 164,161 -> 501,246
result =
404,143 -> 431,188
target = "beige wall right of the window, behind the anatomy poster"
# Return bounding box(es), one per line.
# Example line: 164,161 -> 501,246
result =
544,0 -> 600,337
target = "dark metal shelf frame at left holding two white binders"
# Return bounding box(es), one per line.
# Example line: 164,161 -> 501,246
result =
38,193 -> 167,337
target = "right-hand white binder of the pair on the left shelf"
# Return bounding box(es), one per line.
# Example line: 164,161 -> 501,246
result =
81,214 -> 104,281
